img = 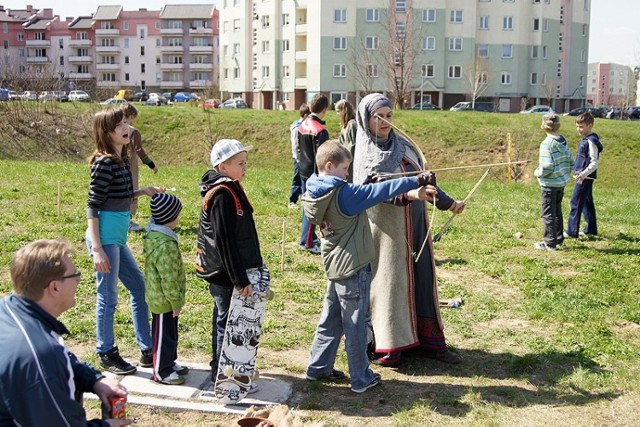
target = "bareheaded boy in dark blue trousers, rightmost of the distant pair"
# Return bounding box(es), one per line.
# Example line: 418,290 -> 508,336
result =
564,113 -> 603,239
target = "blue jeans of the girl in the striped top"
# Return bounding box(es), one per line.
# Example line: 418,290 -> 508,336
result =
87,241 -> 153,353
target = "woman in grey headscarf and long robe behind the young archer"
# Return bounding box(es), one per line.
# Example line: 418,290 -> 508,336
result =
353,93 -> 464,366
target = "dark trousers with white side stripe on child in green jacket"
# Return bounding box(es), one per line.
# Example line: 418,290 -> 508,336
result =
151,311 -> 178,381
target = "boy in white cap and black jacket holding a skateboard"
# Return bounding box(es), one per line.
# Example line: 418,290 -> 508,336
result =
196,139 -> 269,393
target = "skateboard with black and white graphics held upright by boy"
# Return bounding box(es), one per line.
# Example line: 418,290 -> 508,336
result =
213,267 -> 273,404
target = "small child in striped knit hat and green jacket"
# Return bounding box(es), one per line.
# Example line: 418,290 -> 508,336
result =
144,193 -> 189,385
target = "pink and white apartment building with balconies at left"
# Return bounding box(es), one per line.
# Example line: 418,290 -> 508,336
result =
0,4 -> 219,92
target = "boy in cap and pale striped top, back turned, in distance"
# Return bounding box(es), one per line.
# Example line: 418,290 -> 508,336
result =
533,114 -> 573,251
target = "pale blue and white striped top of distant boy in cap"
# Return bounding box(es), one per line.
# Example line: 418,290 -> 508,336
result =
534,134 -> 574,189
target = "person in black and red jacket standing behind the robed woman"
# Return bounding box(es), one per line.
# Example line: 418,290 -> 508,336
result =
298,93 -> 329,254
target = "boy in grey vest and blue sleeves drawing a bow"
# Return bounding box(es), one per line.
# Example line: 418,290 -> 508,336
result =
302,140 -> 436,393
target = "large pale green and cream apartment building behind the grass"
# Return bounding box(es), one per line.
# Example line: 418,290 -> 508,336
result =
219,0 -> 590,111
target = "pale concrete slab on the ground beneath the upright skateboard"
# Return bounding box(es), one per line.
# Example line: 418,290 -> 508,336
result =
85,362 -> 292,414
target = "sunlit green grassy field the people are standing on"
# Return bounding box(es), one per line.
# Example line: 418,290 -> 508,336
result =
0,105 -> 640,426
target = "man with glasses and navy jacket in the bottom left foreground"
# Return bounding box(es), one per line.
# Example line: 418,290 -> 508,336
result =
0,240 -> 133,426
